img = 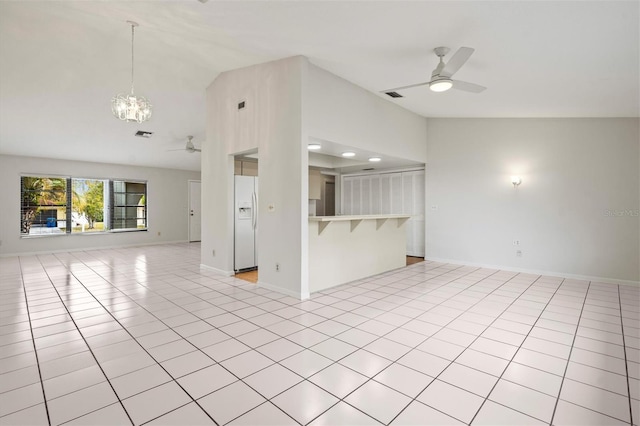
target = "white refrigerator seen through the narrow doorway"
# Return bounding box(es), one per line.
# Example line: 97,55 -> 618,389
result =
234,176 -> 258,271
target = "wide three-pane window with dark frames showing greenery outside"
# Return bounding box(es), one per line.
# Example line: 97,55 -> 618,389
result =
20,176 -> 147,236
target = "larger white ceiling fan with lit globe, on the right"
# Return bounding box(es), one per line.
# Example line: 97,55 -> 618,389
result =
383,47 -> 486,98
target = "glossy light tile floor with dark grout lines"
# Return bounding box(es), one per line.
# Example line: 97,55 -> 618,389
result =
0,244 -> 640,425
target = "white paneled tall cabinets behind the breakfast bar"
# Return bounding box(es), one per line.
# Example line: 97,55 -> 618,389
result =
342,170 -> 425,257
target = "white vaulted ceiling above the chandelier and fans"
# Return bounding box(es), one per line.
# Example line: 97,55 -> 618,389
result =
0,0 -> 640,170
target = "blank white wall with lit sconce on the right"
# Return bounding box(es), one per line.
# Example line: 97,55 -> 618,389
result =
426,118 -> 640,282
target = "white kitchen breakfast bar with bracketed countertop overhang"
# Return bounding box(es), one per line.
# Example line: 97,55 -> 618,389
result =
309,214 -> 411,293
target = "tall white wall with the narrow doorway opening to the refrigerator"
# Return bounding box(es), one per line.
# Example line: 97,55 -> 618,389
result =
202,57 -> 308,297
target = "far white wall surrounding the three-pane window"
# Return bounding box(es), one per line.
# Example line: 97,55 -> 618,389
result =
0,155 -> 200,255
